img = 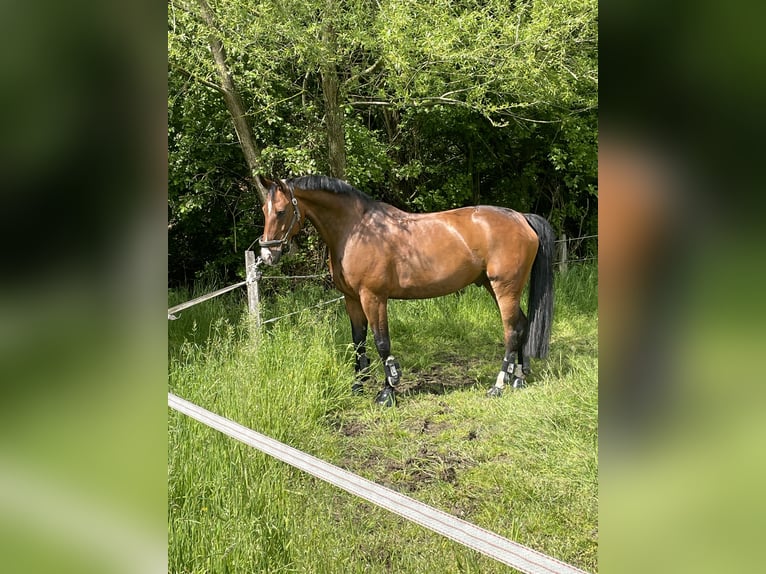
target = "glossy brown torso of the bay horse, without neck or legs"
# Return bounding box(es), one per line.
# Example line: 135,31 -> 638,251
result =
343,206 -> 537,299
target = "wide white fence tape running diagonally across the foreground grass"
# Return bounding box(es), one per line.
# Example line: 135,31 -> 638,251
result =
168,393 -> 584,574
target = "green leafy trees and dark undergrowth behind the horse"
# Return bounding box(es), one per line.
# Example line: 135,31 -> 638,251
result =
168,0 -> 598,284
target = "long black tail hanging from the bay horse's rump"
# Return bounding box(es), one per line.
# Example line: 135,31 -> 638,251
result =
524,213 -> 556,358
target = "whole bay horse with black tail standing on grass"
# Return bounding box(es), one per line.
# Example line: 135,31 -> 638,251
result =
259,176 -> 555,406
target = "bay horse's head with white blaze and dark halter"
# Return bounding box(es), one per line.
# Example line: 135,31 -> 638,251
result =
258,179 -> 301,265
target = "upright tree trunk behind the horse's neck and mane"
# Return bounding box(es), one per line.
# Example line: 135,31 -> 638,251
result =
321,0 -> 346,179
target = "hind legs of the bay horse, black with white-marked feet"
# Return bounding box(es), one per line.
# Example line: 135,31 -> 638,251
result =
485,284 -> 529,397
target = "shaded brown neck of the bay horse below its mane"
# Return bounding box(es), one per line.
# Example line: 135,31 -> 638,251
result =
295,190 -> 364,252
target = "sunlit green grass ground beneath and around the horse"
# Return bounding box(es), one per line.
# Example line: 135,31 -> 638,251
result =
168,266 -> 598,573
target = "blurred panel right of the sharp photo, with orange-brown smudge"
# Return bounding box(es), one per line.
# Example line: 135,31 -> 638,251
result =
599,1 -> 766,572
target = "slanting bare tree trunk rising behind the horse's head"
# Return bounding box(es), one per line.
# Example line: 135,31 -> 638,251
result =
197,0 -> 267,203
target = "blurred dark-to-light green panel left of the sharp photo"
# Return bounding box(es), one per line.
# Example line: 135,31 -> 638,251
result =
0,1 -> 167,572
